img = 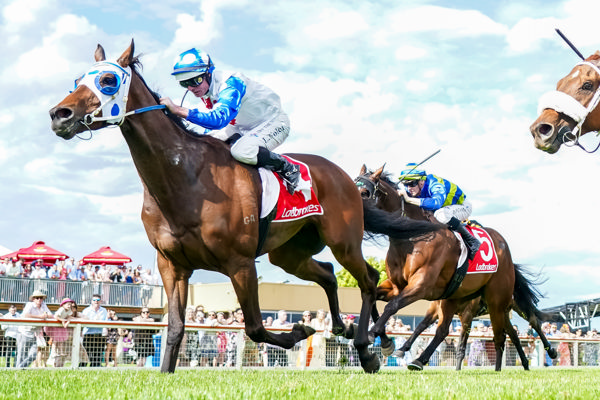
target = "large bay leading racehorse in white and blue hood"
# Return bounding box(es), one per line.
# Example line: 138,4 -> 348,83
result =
50,40 -> 438,372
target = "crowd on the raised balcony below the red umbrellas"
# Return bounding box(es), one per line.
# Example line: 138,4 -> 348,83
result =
0,258 -> 160,285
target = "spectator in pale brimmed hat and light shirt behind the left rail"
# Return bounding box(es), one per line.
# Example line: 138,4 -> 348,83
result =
17,290 -> 52,368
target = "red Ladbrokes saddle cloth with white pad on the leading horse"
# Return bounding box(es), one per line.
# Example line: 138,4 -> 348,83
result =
258,156 -> 323,222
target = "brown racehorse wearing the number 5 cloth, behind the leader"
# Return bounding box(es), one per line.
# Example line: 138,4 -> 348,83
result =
355,165 -> 556,371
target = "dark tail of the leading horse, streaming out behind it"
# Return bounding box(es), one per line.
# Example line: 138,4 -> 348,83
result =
363,199 -> 446,239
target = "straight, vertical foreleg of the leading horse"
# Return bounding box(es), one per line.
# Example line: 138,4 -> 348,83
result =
157,253 -> 190,373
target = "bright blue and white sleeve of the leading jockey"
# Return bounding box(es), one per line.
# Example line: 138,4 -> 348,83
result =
186,76 -> 246,129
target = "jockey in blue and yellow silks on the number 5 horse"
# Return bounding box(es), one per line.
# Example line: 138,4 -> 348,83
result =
398,163 -> 481,260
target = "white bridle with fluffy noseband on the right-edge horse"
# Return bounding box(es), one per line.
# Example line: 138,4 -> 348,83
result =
538,61 -> 600,153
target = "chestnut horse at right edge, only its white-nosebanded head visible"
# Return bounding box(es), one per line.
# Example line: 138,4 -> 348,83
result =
529,51 -> 600,154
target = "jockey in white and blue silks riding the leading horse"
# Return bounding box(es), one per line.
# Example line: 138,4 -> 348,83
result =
160,48 -> 300,194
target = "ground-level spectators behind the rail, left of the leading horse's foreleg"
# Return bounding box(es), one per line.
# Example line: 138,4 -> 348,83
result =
0,290 -> 157,368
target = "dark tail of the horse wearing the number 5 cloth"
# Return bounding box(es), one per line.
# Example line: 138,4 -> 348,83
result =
513,264 -> 549,321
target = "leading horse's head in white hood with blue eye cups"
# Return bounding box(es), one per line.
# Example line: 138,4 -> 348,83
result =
50,39 -> 134,140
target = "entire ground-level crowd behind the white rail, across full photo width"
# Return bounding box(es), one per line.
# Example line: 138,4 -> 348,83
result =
0,290 -> 600,368
